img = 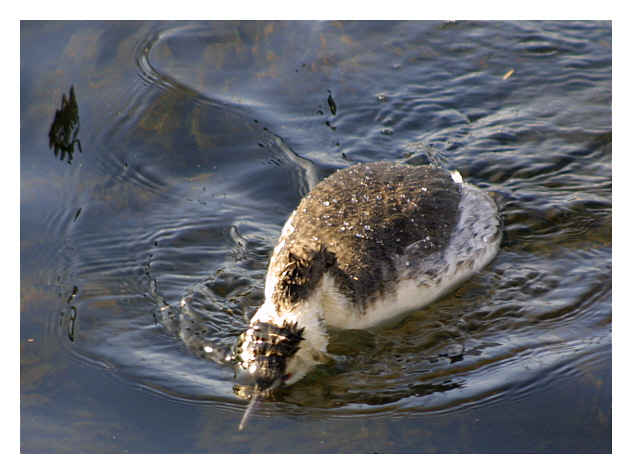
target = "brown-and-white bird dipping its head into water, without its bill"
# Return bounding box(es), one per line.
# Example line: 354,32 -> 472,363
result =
237,162 -> 501,393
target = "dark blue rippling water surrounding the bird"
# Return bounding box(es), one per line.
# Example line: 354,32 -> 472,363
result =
21,22 -> 612,453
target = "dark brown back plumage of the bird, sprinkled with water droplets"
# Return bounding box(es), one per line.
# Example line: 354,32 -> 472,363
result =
270,163 -> 461,311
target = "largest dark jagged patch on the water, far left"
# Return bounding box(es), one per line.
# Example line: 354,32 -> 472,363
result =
48,85 -> 83,163
